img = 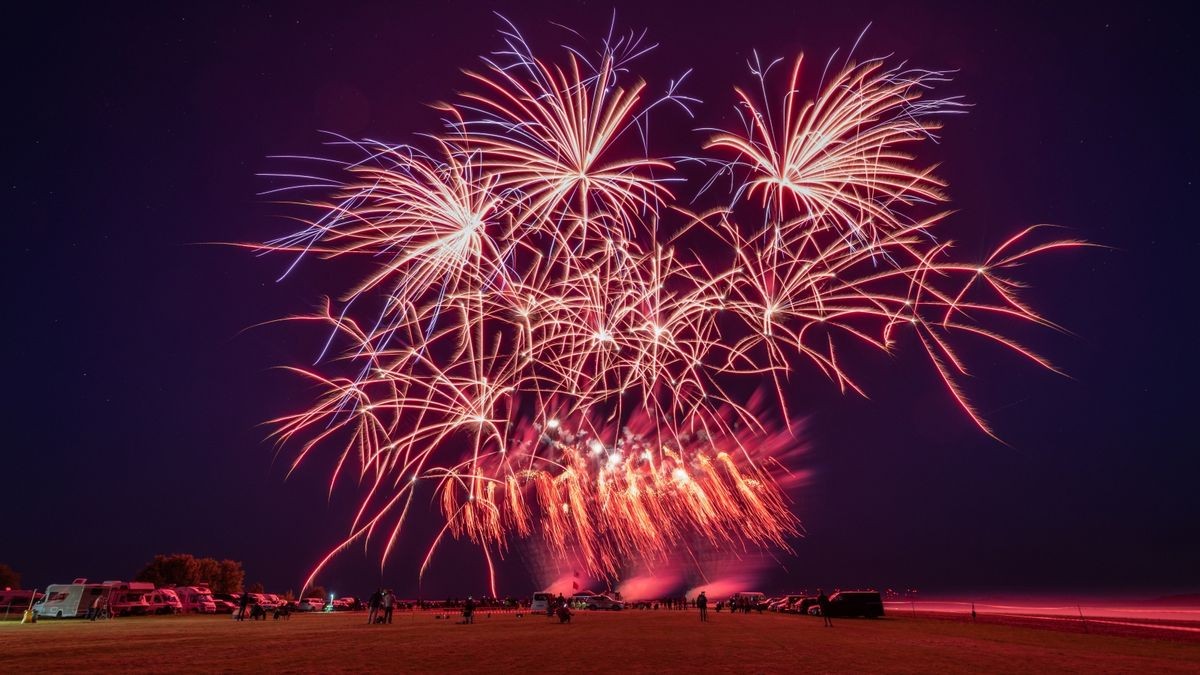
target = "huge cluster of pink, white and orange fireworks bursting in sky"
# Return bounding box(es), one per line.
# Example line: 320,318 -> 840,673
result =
248,18 -> 1080,592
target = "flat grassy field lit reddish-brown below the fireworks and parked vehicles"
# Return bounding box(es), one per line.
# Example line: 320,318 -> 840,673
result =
0,610 -> 1200,673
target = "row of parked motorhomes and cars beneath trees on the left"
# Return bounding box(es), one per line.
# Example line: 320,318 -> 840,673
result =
34,579 -> 358,619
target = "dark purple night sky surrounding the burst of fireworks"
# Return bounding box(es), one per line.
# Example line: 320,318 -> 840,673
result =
0,1 -> 1200,597
